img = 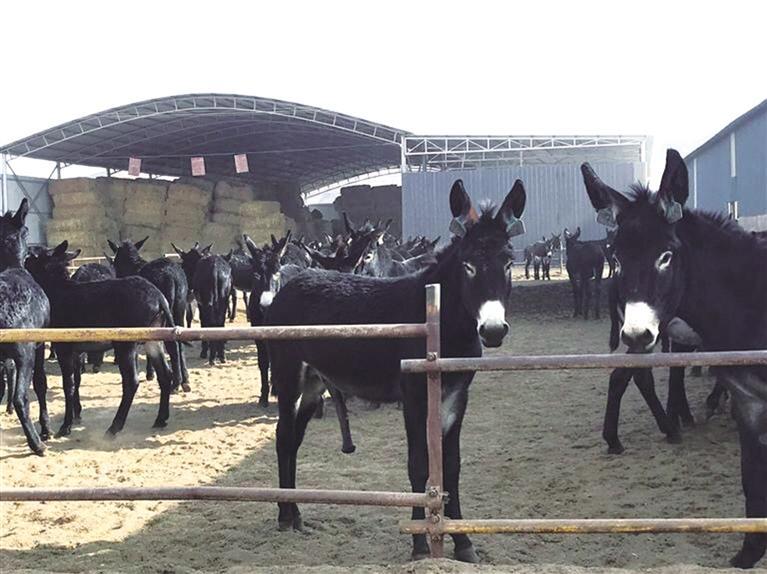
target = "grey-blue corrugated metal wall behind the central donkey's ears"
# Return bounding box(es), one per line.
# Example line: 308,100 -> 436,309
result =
402,162 -> 644,249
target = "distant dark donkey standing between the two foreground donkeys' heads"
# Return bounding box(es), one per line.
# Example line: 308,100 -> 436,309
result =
564,227 -> 605,319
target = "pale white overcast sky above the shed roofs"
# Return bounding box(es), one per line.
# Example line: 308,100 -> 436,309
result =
0,0 -> 767,191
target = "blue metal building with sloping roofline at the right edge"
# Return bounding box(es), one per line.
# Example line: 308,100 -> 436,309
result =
685,100 -> 767,228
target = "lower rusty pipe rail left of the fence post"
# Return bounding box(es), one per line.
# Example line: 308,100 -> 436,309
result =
0,486 -> 431,507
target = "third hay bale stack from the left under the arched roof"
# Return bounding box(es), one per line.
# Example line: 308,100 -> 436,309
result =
162,178 -> 214,249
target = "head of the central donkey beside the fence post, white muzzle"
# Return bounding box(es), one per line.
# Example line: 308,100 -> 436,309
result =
450,179 -> 526,347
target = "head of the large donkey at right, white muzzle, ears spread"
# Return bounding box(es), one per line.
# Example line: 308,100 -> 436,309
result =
581,149 -> 689,352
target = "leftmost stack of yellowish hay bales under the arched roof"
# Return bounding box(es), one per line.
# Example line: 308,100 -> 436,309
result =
46,178 -> 119,256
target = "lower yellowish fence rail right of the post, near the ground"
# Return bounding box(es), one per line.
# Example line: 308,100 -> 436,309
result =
400,518 -> 767,534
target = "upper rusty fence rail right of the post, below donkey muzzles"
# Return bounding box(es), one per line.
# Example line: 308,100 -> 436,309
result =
402,351 -> 767,373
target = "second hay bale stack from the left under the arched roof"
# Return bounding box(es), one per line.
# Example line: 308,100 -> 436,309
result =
120,179 -> 168,257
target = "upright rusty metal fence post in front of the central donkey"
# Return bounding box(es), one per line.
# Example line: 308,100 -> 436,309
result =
426,285 -> 444,558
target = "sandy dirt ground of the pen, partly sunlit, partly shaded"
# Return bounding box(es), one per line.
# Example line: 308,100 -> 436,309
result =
0,282 -> 767,574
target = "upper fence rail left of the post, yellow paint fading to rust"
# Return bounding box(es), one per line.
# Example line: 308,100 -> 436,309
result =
0,323 -> 427,343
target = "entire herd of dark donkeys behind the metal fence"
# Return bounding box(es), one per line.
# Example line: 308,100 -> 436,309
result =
0,150 -> 767,568
